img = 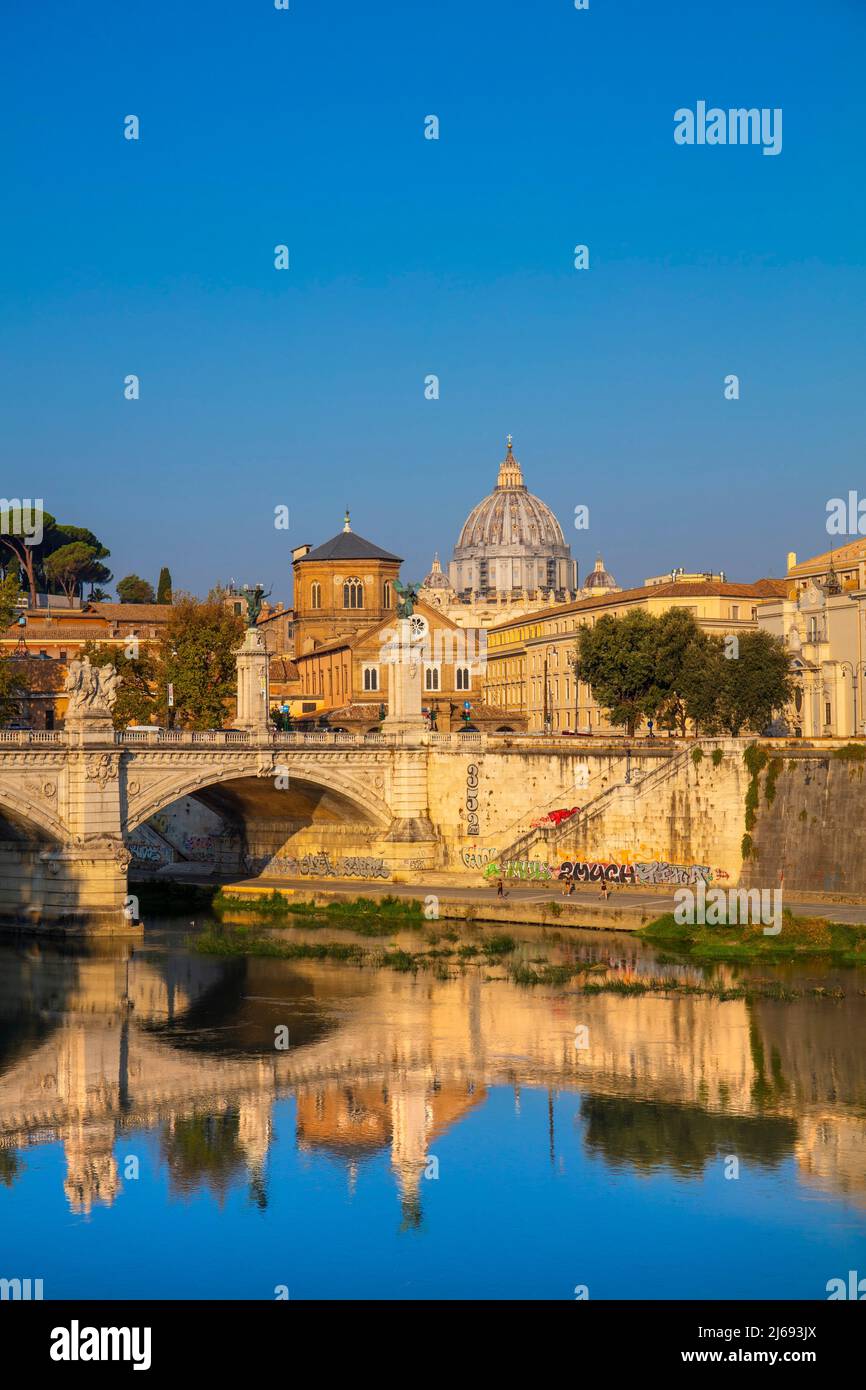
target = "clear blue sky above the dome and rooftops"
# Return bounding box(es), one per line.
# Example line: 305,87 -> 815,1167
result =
0,0 -> 866,598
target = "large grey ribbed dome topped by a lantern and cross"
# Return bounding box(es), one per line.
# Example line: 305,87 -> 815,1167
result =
449,435 -> 575,594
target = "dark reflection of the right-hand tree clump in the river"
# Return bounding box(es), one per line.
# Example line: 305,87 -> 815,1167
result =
581,1095 -> 796,1173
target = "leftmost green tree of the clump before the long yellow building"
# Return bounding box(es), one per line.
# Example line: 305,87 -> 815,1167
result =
578,609 -> 669,734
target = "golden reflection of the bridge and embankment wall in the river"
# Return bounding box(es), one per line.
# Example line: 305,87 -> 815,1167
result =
0,942 -> 866,1209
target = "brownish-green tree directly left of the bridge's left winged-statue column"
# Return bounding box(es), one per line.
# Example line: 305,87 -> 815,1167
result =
158,595 -> 243,728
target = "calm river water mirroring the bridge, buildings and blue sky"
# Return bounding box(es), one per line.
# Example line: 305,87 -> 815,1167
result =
0,923 -> 866,1300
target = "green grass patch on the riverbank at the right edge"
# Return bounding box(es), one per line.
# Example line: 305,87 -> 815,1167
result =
637,912 -> 866,966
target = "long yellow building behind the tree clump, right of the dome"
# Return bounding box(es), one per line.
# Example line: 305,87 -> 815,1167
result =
484,580 -> 788,734
